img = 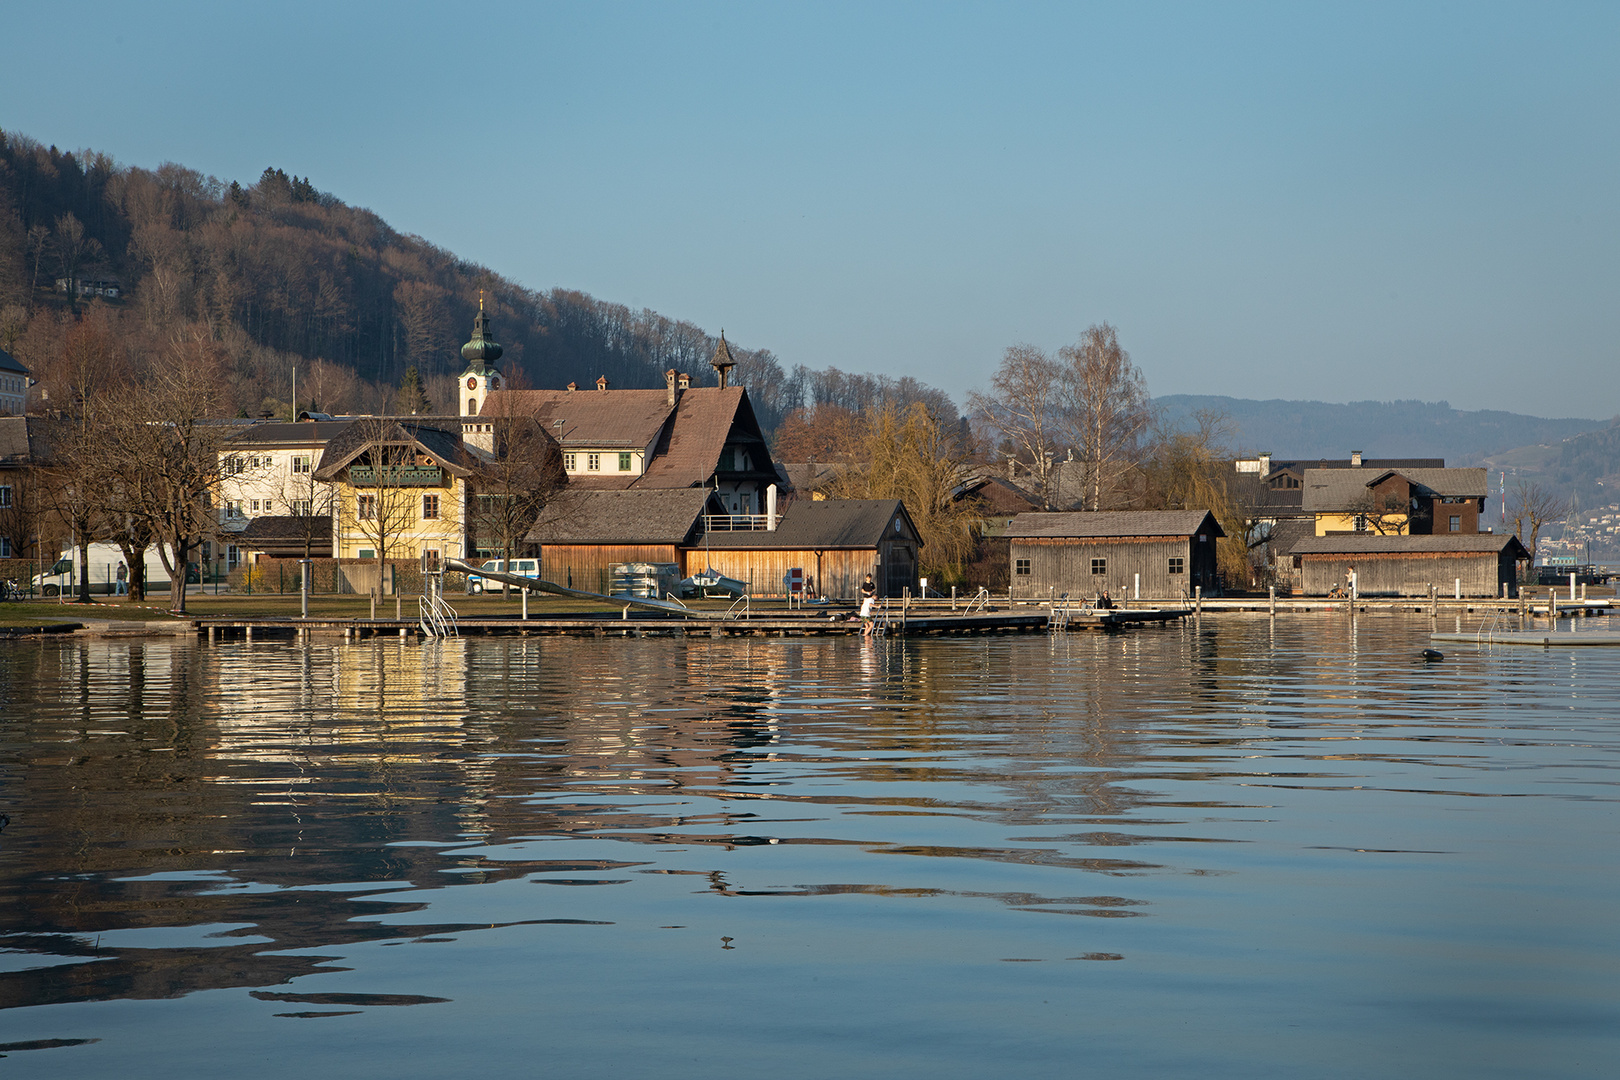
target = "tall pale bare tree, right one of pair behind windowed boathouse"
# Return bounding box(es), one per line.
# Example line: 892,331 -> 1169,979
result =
1058,322 -> 1153,510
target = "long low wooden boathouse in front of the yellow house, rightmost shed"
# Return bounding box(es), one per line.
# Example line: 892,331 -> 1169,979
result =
1293,533 -> 1529,596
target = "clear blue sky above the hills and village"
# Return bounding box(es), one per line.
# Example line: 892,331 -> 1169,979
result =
0,3 -> 1620,418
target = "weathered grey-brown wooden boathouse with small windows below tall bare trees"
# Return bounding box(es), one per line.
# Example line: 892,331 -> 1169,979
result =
1006,510 -> 1225,599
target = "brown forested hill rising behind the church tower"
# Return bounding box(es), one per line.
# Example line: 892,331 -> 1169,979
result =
0,131 -> 954,429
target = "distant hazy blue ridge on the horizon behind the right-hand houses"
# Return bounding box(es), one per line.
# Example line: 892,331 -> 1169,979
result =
1153,393 -> 1609,466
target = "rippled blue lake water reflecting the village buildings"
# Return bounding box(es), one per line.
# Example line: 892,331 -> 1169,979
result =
0,615 -> 1620,1080
